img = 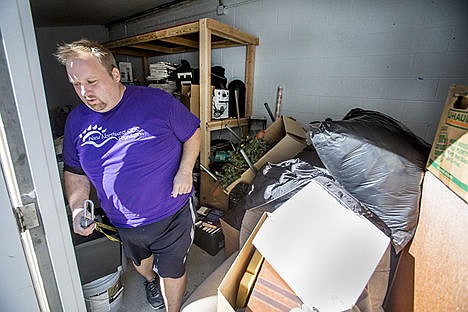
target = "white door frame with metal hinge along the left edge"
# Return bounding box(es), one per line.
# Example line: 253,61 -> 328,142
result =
0,0 -> 85,311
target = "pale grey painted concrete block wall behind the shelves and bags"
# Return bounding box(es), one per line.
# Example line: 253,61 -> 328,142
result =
109,0 -> 468,142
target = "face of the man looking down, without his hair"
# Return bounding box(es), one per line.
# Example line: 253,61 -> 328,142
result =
66,56 -> 122,113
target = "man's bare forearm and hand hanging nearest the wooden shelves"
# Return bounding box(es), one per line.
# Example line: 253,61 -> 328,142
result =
171,128 -> 201,198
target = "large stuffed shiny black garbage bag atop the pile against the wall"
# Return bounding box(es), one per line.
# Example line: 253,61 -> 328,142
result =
309,109 -> 430,253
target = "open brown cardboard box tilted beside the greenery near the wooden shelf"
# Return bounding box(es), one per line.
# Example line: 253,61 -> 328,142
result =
226,116 -> 307,193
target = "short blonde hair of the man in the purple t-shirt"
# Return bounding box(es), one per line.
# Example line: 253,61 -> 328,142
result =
54,39 -> 117,74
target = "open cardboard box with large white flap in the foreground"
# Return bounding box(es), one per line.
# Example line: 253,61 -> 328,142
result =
217,182 -> 390,312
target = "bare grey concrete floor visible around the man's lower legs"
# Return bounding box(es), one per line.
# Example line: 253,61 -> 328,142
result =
118,244 -> 225,312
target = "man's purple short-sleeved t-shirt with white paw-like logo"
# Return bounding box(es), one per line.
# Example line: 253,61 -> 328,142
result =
63,86 -> 200,227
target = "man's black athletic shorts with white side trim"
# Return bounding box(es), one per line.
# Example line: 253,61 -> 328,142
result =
119,199 -> 195,278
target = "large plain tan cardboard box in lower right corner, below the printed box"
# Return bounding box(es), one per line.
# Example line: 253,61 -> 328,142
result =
385,172 -> 468,312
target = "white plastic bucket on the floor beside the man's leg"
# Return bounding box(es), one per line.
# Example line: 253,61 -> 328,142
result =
83,266 -> 124,312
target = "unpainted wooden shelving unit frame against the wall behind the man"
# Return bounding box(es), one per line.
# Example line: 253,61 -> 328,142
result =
104,18 -> 259,167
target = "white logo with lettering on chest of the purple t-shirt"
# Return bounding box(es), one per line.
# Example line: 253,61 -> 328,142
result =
79,125 -> 145,148
